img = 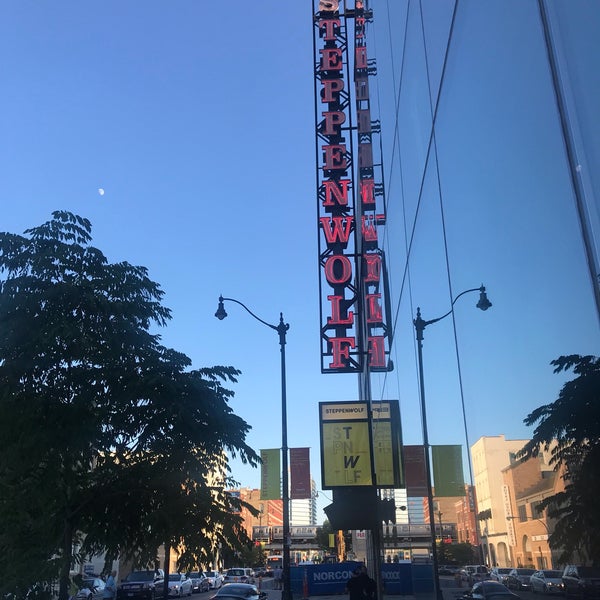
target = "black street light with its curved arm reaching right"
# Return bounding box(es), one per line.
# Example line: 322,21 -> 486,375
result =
413,285 -> 492,600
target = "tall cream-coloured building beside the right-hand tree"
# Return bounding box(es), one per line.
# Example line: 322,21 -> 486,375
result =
471,435 -> 528,567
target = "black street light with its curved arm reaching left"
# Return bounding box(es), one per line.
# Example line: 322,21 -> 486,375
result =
215,296 -> 292,600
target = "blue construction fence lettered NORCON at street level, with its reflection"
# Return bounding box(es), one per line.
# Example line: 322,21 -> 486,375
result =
290,561 -> 433,597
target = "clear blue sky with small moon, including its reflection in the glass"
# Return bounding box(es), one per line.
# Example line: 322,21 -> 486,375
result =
0,0 -> 600,524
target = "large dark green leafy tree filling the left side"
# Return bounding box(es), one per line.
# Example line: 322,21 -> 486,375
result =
0,212 -> 259,600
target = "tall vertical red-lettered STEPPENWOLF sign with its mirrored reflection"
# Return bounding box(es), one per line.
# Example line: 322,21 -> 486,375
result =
313,0 -> 392,373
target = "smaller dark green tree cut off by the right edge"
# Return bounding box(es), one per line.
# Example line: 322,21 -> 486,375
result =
520,355 -> 600,565
